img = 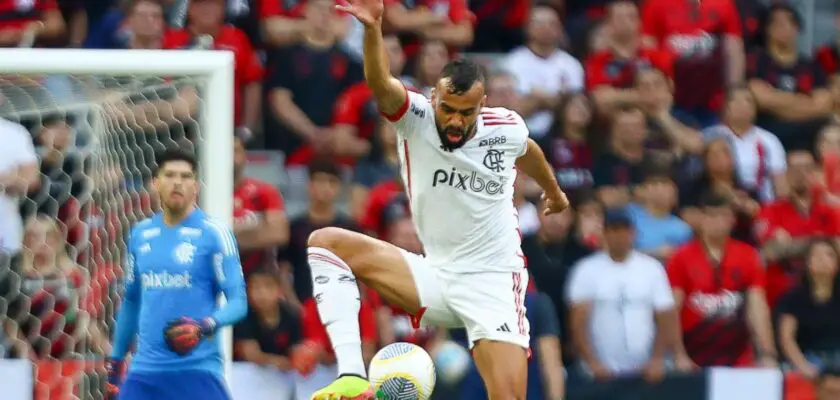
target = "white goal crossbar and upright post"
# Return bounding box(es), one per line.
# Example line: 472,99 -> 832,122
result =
0,49 -> 234,388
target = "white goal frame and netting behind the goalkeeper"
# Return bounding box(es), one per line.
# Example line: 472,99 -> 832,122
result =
0,50 -> 233,400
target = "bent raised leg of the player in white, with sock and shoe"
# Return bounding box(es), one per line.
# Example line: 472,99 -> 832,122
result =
308,228 -> 421,399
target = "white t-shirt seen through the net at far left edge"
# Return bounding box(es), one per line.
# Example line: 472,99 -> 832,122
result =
0,118 -> 38,253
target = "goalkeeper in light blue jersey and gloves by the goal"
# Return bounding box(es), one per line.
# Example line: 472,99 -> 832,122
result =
108,150 -> 248,400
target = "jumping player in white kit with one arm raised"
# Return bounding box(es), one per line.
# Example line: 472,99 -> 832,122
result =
308,0 -> 568,400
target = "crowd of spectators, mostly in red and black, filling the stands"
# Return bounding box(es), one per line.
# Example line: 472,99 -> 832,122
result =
0,0 -> 840,399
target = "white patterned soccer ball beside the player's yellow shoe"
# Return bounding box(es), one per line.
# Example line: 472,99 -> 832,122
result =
368,343 -> 435,400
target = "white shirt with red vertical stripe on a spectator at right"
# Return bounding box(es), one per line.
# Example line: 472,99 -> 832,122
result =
703,124 -> 787,203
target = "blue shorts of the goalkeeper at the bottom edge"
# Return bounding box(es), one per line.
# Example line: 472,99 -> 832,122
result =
119,370 -> 231,400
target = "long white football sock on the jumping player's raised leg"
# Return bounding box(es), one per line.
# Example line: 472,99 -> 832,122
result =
307,247 -> 367,377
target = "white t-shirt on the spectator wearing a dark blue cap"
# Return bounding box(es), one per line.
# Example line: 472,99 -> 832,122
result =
568,251 -> 674,374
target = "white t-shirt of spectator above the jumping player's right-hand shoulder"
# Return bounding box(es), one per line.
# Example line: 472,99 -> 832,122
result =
503,46 -> 584,138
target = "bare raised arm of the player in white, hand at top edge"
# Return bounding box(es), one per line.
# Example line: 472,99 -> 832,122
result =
336,0 -> 408,116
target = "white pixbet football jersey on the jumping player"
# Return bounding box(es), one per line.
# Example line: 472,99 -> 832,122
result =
391,91 -> 528,272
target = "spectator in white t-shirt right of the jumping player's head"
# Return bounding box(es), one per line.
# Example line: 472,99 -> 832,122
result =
503,6 -> 583,138
